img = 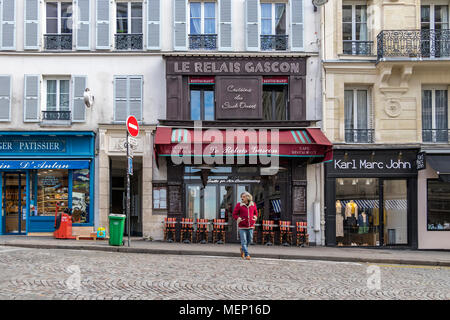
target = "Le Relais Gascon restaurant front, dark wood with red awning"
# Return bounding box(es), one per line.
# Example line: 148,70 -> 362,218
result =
153,56 -> 332,242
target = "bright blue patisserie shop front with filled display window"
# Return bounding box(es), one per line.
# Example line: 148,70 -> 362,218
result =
0,131 -> 95,235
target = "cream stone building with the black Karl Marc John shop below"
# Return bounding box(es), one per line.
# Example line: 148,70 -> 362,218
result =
321,0 -> 450,249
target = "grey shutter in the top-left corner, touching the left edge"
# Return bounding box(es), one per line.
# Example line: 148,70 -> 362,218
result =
0,0 -> 16,50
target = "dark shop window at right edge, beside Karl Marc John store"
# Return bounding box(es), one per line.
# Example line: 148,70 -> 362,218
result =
427,180 -> 450,231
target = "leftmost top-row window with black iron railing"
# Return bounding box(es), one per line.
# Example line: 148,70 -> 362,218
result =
44,1 -> 73,50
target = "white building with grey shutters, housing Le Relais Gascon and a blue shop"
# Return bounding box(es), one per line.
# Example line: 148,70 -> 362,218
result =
0,0 -> 331,245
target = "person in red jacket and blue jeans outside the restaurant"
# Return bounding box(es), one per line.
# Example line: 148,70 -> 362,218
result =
233,192 -> 258,260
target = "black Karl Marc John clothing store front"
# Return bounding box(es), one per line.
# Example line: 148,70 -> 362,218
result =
325,149 -> 417,248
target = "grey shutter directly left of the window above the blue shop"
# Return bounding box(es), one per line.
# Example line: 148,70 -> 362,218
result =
23,74 -> 41,122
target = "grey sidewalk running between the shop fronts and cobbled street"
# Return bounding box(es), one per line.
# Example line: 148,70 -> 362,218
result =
0,236 -> 450,267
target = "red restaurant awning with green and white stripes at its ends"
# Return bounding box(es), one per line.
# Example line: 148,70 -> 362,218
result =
155,127 -> 333,162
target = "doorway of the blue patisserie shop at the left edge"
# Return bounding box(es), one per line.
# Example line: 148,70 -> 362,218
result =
2,172 -> 27,234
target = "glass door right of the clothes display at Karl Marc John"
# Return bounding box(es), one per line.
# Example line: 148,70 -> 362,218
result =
383,179 -> 408,245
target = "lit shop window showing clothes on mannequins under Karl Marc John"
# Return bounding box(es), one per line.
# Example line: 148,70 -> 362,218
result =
336,178 -> 380,246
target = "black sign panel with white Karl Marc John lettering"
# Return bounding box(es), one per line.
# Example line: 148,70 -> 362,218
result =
327,150 -> 417,174
